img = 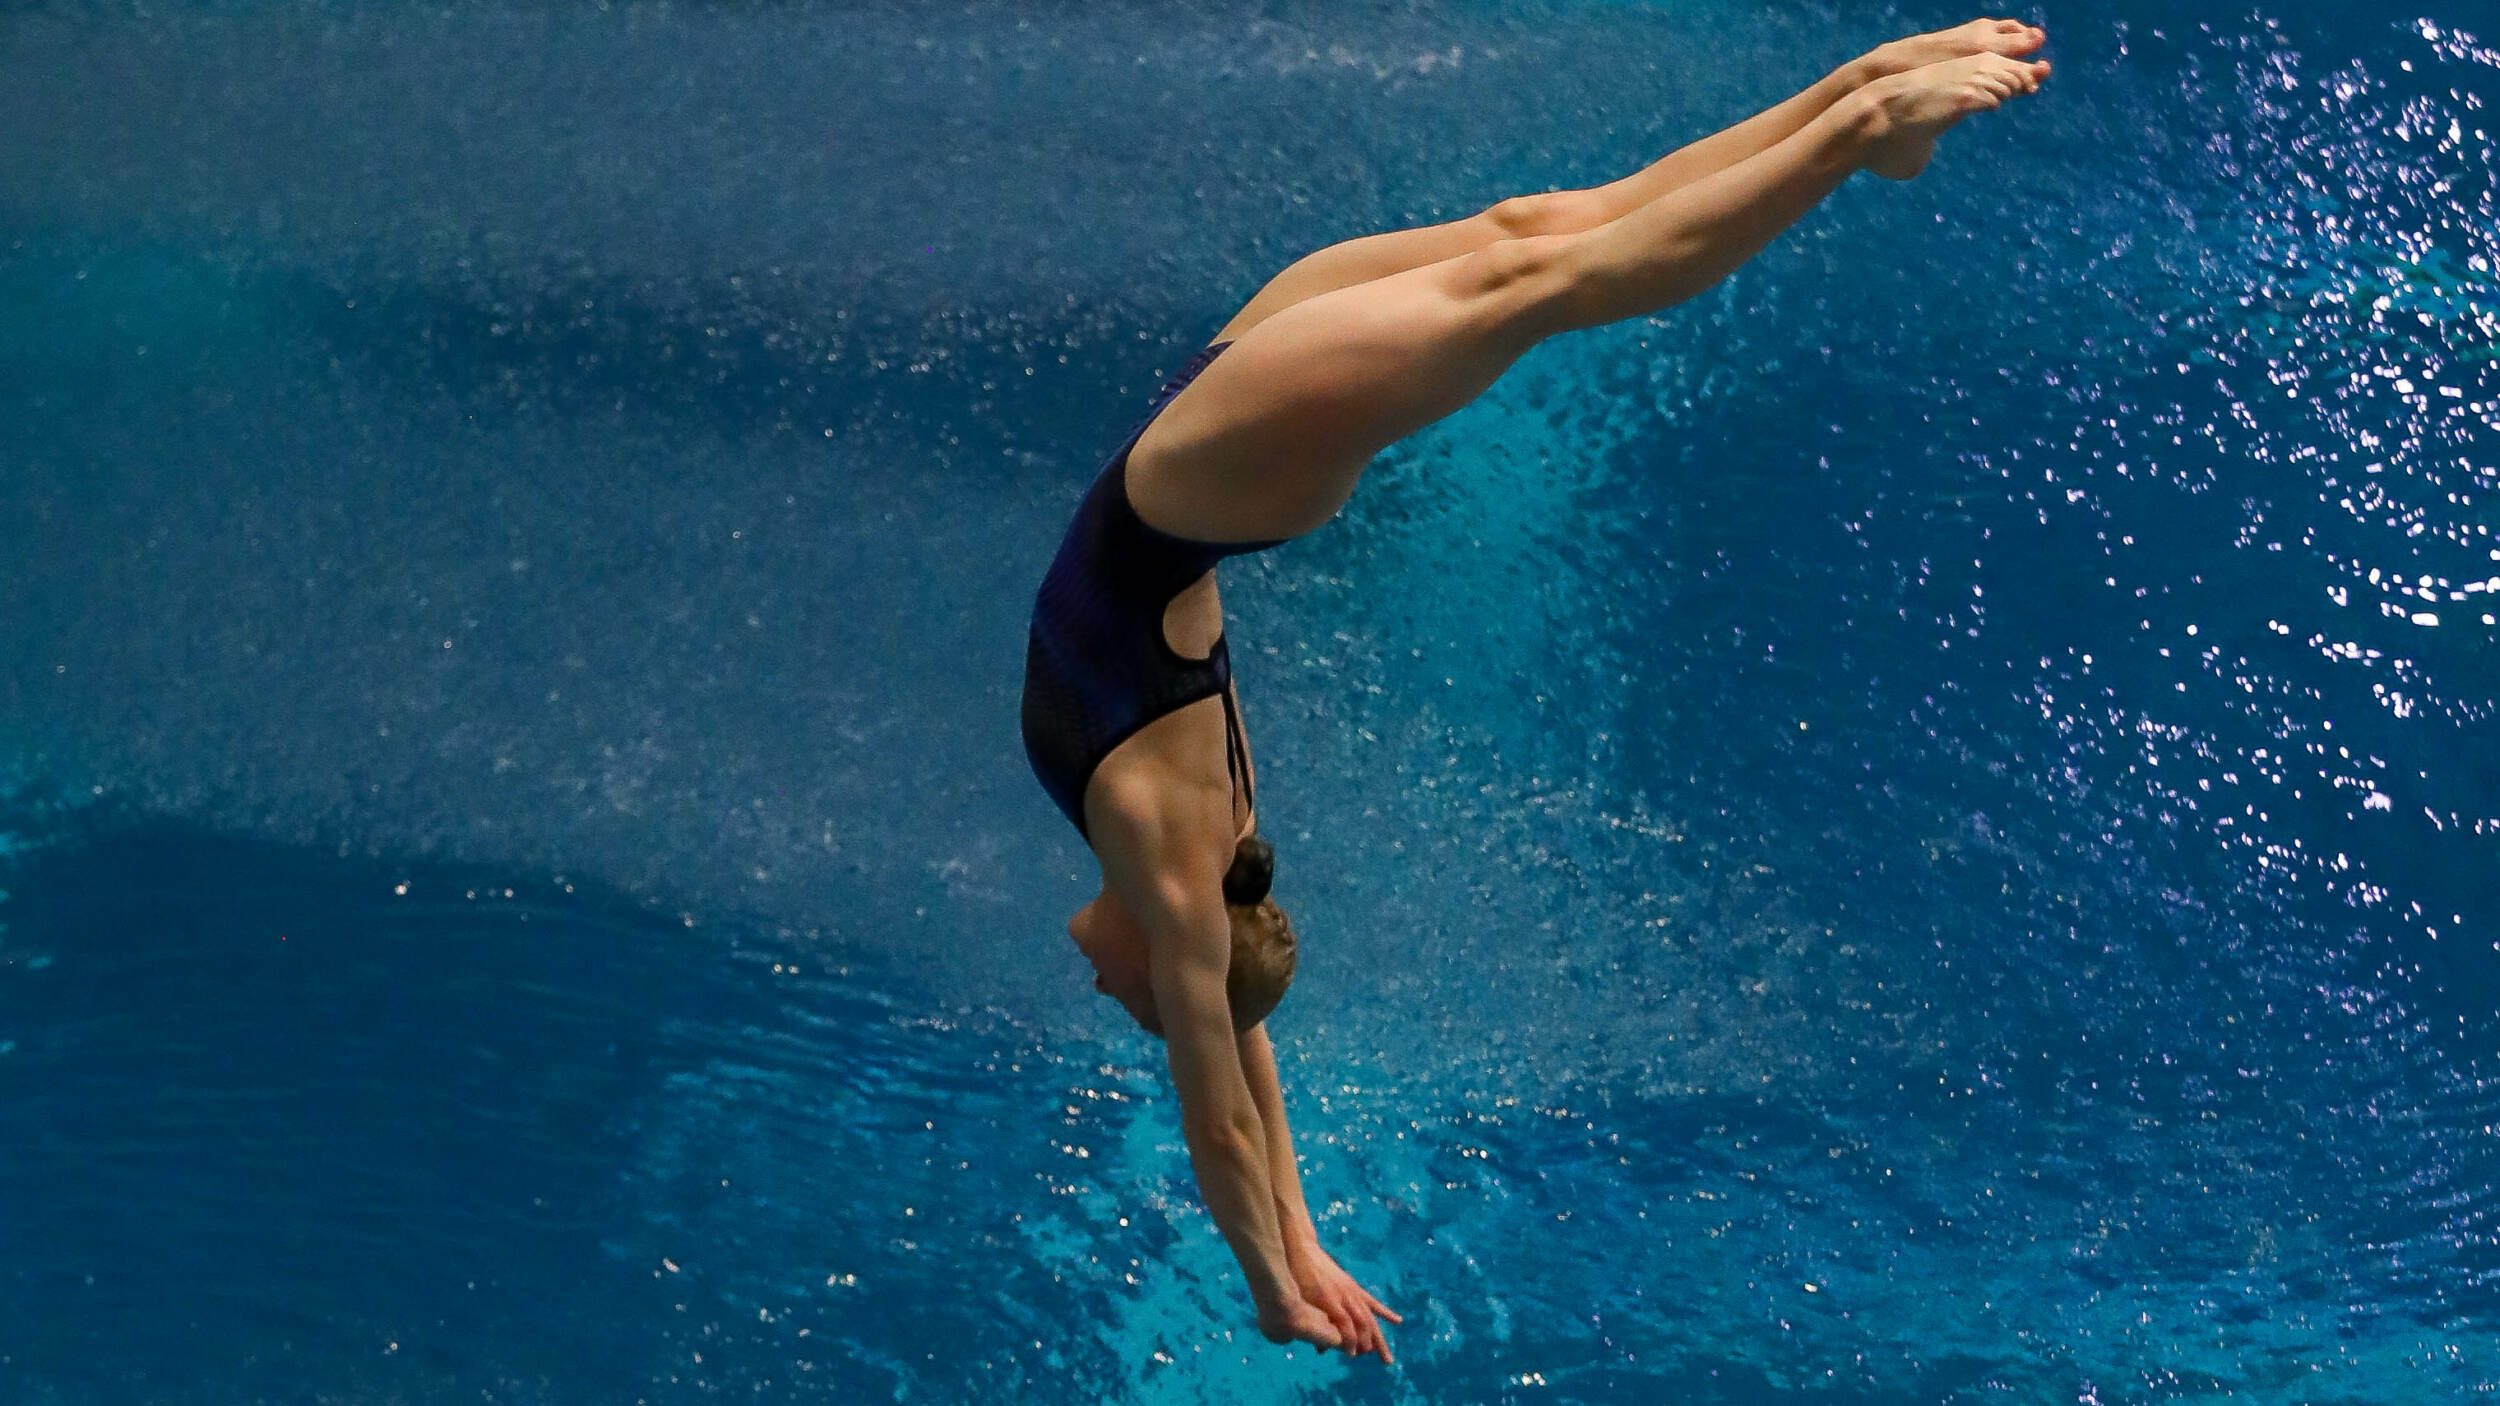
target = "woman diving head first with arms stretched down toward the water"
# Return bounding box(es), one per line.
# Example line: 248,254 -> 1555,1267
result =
1023,20 -> 2048,1363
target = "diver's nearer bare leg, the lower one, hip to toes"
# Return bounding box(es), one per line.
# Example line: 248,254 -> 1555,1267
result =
1128,53 -> 2048,540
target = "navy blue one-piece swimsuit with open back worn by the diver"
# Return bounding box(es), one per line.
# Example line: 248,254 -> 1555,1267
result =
1025,343 -> 1285,841
